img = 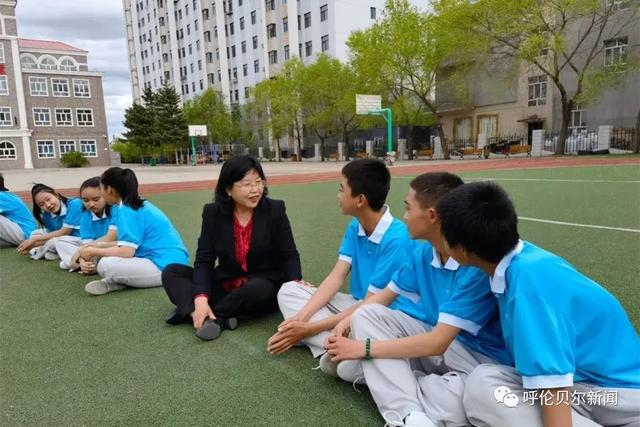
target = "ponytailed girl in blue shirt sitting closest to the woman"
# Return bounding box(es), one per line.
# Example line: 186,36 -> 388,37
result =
80,167 -> 189,295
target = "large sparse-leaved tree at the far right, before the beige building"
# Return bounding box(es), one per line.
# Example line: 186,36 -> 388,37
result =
436,0 -> 638,154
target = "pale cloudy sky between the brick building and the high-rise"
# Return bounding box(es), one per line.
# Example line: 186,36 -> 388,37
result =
17,0 -> 131,138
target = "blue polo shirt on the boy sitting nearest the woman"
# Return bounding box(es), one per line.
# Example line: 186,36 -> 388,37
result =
338,206 -> 422,318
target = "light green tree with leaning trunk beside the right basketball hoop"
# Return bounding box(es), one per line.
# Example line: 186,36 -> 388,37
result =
347,0 -> 457,159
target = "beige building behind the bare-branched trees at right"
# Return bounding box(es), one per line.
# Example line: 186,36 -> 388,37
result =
436,6 -> 640,147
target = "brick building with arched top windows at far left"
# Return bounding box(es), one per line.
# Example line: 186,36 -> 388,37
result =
0,0 -> 111,170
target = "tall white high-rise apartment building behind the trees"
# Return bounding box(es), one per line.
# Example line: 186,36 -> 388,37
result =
123,0 -> 398,104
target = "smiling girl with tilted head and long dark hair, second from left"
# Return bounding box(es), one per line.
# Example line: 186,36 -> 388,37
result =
17,184 -> 82,260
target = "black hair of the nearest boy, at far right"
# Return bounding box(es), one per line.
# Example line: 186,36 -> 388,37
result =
437,181 -> 520,262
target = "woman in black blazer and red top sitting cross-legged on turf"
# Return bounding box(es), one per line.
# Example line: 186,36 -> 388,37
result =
162,155 -> 302,340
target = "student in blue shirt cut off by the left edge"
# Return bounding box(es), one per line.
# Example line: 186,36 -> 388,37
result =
0,173 -> 36,247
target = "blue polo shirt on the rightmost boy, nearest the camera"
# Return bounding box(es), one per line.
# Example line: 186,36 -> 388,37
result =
491,241 -> 640,389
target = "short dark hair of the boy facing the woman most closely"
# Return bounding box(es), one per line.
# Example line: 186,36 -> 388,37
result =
342,159 -> 391,211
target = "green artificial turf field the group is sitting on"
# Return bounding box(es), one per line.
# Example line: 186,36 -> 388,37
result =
0,165 -> 640,426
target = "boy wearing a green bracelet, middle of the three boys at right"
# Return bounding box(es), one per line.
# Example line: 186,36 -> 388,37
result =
327,172 -> 511,427
